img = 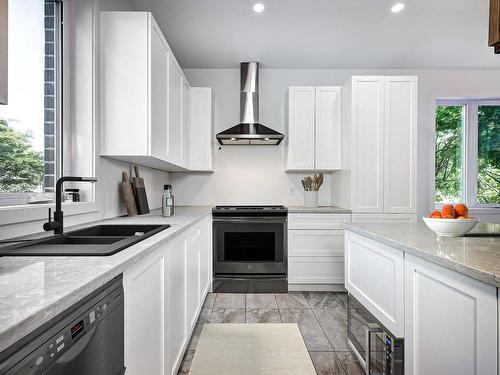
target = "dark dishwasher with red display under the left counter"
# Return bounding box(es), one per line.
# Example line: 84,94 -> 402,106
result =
0,275 -> 125,375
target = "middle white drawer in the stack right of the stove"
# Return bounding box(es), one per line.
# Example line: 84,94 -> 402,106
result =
288,229 -> 344,257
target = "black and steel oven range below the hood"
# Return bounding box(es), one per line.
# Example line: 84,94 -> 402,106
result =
212,206 -> 288,293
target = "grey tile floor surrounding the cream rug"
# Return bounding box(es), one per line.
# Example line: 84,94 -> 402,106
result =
179,292 -> 364,375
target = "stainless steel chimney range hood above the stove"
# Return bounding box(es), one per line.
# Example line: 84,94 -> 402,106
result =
216,62 -> 284,145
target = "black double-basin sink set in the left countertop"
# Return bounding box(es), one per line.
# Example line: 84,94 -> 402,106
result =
0,224 -> 170,256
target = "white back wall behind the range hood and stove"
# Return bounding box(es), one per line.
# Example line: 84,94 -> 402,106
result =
172,69 -> 500,221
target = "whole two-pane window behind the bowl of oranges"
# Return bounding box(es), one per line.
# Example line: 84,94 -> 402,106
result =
435,99 -> 500,207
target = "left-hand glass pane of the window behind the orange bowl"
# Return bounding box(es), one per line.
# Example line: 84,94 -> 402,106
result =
435,105 -> 465,203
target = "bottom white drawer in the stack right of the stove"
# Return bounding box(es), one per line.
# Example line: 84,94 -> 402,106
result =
288,257 -> 344,284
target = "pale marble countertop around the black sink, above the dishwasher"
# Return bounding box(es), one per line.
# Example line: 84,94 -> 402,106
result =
0,207 -> 212,352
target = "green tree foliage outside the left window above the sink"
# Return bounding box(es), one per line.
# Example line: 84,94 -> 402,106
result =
0,119 -> 44,192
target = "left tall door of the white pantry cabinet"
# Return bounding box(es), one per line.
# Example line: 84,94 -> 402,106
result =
351,77 -> 385,212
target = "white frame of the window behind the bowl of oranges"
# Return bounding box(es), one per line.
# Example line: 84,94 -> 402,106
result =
433,98 -> 500,211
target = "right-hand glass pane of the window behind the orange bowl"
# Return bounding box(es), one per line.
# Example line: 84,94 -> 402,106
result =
477,105 -> 500,204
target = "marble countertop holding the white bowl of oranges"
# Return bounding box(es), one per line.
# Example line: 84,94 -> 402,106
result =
344,223 -> 500,288
